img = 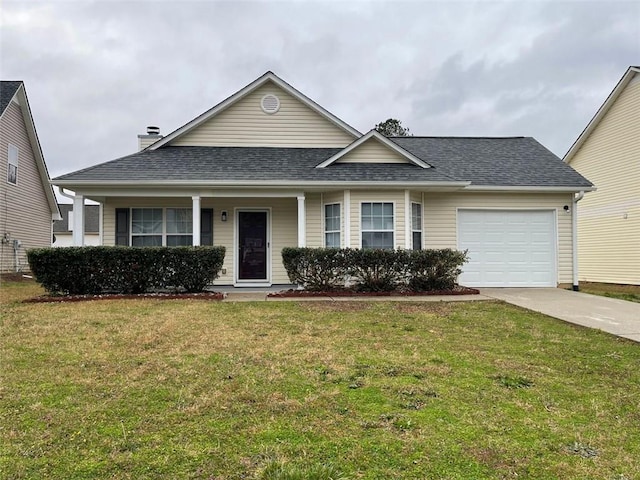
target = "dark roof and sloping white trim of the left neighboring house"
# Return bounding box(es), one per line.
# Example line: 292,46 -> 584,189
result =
0,81 -> 60,220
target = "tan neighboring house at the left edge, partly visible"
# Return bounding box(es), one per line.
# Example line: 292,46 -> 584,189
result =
0,81 -> 60,273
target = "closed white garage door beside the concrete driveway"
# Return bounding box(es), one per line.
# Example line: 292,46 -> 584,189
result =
458,210 -> 557,287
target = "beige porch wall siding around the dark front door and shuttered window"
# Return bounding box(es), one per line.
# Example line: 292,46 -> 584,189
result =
104,197 -> 298,285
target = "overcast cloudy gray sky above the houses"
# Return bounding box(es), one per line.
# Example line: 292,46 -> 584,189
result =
0,0 -> 640,188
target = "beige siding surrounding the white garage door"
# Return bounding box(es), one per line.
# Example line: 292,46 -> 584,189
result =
423,193 -> 573,283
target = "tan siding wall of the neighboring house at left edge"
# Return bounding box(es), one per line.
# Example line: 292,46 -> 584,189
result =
0,102 -> 52,272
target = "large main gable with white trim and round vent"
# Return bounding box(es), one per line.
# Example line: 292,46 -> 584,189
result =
148,72 -> 360,150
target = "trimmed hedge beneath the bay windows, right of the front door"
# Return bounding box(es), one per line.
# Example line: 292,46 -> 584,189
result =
282,247 -> 468,292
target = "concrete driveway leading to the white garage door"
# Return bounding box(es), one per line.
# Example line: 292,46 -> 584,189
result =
480,288 -> 640,342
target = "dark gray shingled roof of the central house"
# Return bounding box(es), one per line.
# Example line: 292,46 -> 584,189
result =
54,137 -> 591,187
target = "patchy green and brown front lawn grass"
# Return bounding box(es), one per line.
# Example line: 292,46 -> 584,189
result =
0,283 -> 640,480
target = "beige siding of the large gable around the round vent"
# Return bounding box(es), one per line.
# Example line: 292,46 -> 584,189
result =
171,82 -> 355,147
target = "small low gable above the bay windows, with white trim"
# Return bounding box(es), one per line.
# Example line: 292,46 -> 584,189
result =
316,130 -> 430,168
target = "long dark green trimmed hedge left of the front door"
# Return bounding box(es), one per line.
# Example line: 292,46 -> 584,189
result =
27,247 -> 225,295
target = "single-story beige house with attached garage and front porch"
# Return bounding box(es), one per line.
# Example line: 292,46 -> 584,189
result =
54,72 -> 592,286
